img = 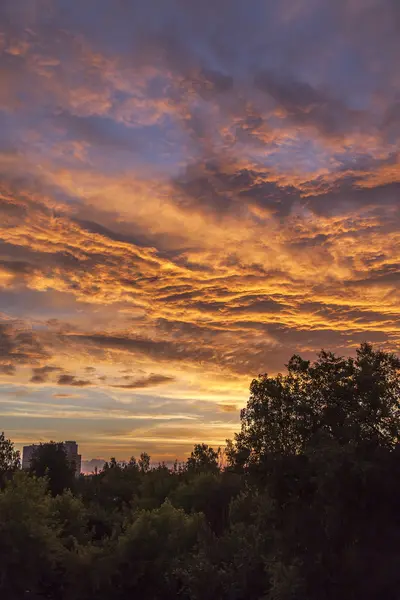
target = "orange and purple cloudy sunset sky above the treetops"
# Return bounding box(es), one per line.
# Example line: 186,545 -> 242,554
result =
0,0 -> 400,461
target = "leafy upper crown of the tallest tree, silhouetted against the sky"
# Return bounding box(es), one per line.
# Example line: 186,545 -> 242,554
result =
228,344 -> 400,465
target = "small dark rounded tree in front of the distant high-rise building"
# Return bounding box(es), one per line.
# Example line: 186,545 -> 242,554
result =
30,442 -> 75,496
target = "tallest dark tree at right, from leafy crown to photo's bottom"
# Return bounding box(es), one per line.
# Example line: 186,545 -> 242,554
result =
227,344 -> 400,600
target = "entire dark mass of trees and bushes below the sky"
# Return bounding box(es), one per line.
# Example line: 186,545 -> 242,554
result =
0,344 -> 400,600
